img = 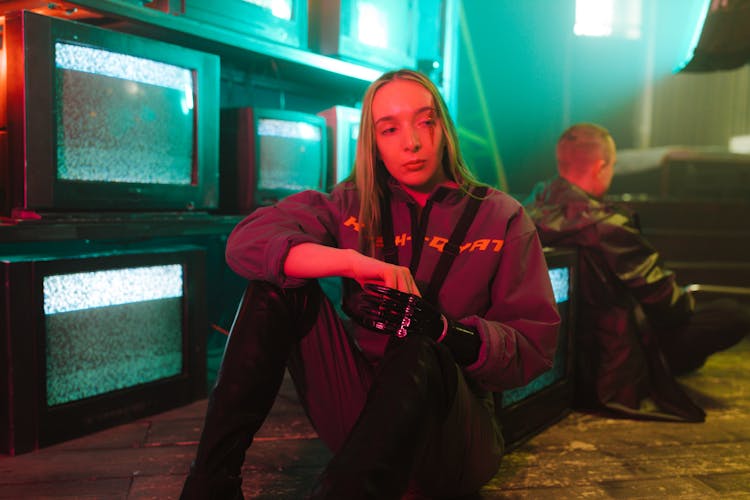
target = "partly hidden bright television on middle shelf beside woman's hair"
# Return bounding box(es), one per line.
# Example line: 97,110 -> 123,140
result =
318,106 -> 362,188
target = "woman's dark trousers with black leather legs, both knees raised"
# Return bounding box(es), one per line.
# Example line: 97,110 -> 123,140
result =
182,281 -> 502,499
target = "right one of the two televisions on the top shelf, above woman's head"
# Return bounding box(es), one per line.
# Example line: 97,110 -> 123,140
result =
310,0 -> 419,70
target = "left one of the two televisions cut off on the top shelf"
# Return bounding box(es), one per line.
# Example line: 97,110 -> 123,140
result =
182,0 -> 308,49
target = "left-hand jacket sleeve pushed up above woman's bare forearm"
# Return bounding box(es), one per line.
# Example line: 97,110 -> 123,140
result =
226,191 -> 340,287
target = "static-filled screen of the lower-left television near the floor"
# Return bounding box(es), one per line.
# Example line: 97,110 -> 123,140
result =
43,264 -> 185,407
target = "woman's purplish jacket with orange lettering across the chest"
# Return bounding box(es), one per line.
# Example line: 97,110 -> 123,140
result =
226,183 -> 559,391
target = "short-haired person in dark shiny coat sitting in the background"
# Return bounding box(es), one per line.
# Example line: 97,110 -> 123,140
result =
524,123 -> 750,422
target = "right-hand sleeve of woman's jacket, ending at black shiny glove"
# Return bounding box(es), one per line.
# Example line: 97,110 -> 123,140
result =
461,211 -> 560,391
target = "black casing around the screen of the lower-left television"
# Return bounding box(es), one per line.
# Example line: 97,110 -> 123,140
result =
0,245 -> 207,455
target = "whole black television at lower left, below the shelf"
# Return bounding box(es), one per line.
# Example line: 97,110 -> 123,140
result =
0,245 -> 207,455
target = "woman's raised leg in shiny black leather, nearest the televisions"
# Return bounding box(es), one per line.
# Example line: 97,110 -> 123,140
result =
180,281 -> 321,500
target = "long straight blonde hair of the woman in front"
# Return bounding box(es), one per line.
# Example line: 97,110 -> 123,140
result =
352,69 -> 479,255
